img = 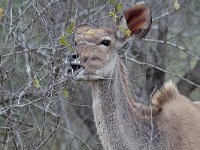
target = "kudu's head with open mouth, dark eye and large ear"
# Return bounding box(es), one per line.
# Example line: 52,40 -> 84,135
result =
68,2 -> 151,80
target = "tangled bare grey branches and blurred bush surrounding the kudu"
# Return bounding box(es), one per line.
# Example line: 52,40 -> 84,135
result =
0,0 -> 200,150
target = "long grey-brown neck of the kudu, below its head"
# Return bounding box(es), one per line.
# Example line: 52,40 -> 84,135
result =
92,58 -> 150,150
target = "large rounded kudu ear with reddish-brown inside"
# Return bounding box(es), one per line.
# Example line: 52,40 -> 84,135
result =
117,2 -> 152,41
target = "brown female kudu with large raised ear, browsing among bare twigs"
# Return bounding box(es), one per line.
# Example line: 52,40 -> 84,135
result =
68,2 -> 200,150
